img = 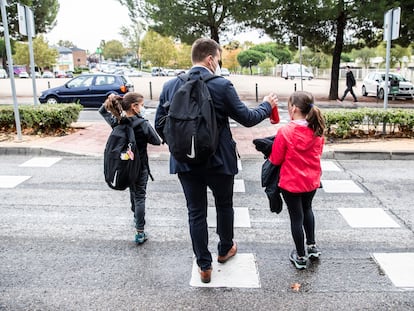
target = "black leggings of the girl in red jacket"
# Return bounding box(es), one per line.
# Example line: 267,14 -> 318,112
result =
281,189 -> 316,257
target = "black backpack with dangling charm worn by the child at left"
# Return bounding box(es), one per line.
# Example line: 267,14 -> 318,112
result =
104,119 -> 144,190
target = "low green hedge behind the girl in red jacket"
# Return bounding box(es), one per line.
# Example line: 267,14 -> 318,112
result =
322,108 -> 414,138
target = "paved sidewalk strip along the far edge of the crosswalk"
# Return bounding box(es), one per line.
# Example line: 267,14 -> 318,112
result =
0,122 -> 414,160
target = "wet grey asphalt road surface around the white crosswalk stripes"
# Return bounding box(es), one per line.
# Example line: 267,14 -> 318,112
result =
0,155 -> 414,311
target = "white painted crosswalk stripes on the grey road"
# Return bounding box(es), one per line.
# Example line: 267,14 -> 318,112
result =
0,157 -> 414,289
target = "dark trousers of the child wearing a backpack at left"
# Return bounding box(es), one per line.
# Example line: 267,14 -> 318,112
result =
129,167 -> 148,230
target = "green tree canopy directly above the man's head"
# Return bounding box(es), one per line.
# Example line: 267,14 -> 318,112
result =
119,0 -> 254,44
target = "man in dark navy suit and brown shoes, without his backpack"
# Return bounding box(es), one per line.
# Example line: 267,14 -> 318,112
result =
155,38 -> 277,283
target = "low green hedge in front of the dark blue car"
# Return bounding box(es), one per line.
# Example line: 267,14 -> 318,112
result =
0,104 -> 83,134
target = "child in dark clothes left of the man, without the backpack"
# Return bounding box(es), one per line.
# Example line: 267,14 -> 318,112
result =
99,92 -> 161,244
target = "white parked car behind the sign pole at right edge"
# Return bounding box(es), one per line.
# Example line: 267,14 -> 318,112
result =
362,72 -> 414,99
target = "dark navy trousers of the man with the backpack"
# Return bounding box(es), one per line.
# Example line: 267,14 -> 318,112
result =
178,172 -> 234,270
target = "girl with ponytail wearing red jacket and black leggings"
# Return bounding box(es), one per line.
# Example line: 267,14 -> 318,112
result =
269,91 -> 325,269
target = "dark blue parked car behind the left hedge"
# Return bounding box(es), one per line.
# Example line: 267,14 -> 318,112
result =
39,73 -> 134,107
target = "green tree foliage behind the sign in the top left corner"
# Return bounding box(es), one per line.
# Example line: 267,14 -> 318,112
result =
0,0 -> 59,40
